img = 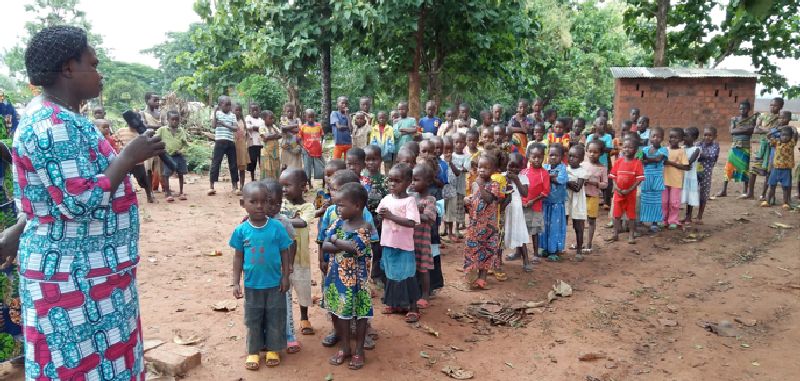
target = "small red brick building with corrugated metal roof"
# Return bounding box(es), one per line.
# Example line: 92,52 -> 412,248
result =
611,67 -> 757,141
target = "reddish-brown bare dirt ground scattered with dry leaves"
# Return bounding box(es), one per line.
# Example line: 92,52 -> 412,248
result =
0,141 -> 800,381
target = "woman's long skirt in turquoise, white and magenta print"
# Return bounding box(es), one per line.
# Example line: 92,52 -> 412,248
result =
20,269 -> 145,381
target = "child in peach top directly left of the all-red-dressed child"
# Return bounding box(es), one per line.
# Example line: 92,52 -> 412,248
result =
582,140 -> 608,254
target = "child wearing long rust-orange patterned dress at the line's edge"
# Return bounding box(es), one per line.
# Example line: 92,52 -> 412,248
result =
464,153 -> 503,289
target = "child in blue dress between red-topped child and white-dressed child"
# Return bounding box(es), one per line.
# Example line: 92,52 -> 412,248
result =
539,144 -> 569,262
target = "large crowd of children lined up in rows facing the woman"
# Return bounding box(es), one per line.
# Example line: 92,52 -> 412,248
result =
220,97 -> 800,369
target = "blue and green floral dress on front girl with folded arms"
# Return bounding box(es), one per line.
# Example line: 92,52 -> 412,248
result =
322,219 -> 374,319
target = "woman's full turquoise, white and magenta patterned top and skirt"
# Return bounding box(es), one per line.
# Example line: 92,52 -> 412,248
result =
12,97 -> 144,380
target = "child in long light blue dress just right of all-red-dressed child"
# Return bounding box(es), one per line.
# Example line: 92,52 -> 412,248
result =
639,127 -> 669,233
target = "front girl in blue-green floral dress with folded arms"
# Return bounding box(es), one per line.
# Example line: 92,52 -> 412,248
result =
322,183 -> 377,370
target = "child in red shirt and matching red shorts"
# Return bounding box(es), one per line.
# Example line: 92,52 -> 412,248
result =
608,140 -> 652,243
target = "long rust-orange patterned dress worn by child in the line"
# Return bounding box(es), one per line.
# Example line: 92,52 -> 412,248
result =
464,181 -> 503,273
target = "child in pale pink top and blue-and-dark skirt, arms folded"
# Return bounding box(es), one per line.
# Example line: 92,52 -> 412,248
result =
378,163 -> 420,323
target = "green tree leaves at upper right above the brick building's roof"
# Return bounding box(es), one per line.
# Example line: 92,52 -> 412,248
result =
624,0 -> 800,97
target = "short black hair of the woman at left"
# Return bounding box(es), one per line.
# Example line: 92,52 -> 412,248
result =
25,25 -> 89,86
